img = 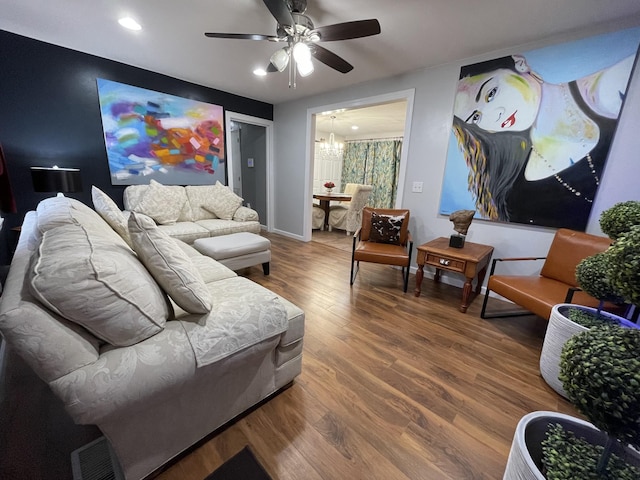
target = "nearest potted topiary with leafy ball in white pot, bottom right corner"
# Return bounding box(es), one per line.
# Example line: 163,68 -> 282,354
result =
504,326 -> 640,480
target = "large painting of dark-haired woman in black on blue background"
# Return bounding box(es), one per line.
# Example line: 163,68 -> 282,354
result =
439,27 -> 640,230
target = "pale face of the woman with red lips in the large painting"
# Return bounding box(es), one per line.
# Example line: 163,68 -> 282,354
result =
454,68 -> 541,132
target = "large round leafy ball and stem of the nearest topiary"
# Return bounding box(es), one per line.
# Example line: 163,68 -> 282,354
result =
559,326 -> 640,474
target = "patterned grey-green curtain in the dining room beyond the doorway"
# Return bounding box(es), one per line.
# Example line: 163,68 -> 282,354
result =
341,138 -> 402,208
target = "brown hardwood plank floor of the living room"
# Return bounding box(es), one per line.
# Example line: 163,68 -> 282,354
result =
0,232 -> 577,480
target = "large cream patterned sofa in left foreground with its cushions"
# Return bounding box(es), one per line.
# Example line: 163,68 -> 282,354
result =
0,195 -> 304,480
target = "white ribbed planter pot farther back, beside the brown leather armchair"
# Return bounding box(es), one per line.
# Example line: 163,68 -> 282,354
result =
540,303 -> 634,398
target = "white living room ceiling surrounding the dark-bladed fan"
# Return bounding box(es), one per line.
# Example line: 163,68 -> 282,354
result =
0,0 -> 640,137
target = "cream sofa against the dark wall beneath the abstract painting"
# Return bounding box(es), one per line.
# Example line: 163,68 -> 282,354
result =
123,180 -> 260,244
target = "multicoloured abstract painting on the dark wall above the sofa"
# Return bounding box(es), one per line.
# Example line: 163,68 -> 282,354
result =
97,78 -> 226,185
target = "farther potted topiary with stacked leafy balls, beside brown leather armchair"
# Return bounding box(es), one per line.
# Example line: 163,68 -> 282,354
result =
540,201 -> 640,398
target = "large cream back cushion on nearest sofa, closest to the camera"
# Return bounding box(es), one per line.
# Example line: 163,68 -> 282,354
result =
29,221 -> 169,346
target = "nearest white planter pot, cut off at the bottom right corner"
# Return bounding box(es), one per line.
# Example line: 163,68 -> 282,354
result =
502,411 -> 640,480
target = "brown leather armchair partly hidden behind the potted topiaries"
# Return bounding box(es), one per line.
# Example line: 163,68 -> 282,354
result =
480,228 -> 615,319
